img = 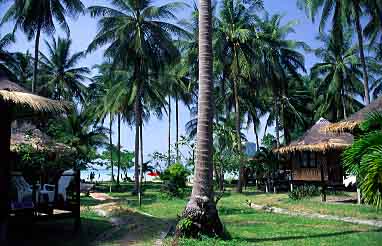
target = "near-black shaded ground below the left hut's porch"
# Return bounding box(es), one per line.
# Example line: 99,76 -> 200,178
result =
8,218 -> 112,246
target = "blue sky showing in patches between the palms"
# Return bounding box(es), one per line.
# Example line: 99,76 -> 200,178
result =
0,0 -> 320,159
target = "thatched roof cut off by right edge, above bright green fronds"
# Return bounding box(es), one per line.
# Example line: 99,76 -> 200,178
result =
322,96 -> 382,133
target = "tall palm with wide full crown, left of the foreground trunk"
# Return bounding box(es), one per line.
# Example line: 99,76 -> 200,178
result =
88,0 -> 185,195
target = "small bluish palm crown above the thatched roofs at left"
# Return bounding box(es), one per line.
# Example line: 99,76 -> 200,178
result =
39,38 -> 90,102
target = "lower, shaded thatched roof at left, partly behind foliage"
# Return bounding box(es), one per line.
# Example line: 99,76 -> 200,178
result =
11,122 -> 72,153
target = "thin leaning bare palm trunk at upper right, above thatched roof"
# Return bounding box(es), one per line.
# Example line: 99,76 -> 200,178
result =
353,0 -> 370,105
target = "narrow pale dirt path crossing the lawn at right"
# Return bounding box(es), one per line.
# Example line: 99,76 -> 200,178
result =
249,203 -> 382,228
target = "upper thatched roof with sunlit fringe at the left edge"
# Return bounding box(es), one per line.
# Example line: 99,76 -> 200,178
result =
0,77 -> 68,113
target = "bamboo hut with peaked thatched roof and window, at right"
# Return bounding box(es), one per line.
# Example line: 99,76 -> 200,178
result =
275,118 -> 353,193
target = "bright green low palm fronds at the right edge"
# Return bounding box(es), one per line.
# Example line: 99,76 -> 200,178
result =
343,112 -> 382,208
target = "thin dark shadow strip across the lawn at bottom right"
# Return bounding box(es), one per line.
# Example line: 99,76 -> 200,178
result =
235,229 -> 381,243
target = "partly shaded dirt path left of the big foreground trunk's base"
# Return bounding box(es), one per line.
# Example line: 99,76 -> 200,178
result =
92,193 -> 172,245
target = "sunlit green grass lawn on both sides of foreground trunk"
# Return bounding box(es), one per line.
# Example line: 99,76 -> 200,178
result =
100,184 -> 382,245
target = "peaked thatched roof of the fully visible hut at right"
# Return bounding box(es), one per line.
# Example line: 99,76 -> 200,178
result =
275,118 -> 353,154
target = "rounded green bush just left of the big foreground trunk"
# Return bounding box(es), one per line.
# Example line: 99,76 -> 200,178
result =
160,163 -> 190,197
